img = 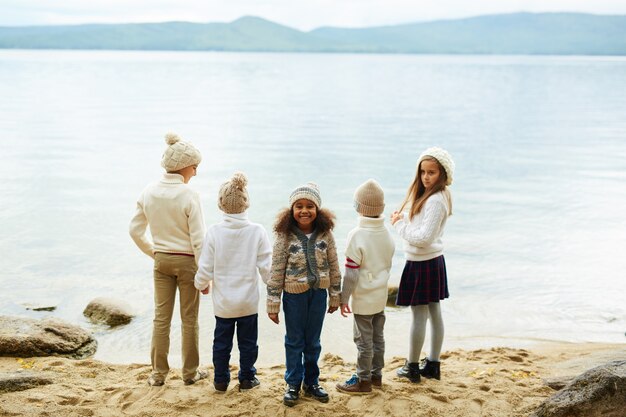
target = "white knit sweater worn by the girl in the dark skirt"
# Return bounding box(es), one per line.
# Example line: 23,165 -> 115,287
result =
394,191 -> 450,261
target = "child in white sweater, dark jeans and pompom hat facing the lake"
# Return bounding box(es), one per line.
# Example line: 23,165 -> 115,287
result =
195,173 -> 272,392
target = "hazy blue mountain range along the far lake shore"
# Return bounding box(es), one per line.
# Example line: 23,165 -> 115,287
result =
0,13 -> 626,55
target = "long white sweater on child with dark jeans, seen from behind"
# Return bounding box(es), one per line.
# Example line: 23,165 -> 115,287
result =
195,212 -> 272,318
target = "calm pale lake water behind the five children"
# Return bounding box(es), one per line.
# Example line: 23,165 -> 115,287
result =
0,50 -> 626,366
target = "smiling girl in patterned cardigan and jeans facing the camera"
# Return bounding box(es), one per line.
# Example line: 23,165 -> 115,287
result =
267,183 -> 341,407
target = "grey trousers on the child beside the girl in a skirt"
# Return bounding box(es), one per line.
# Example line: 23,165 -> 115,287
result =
354,311 -> 385,381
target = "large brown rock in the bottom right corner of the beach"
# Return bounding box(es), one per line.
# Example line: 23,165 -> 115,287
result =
532,360 -> 626,417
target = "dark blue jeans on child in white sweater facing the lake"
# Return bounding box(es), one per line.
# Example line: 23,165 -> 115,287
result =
213,314 -> 259,383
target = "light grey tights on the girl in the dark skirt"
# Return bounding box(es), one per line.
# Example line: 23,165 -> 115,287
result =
409,303 -> 444,363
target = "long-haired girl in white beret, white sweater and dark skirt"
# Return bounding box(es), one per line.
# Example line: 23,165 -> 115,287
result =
391,148 -> 454,383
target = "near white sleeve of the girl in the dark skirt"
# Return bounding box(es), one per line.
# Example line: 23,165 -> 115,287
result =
394,201 -> 447,247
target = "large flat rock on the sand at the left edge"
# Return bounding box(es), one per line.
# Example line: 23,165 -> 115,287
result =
0,316 -> 98,359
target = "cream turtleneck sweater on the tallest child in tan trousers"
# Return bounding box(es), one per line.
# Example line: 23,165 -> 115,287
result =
129,174 -> 205,263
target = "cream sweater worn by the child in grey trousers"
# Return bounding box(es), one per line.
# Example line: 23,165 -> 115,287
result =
342,216 -> 395,314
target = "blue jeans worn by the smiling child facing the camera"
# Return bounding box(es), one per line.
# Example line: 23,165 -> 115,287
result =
283,289 -> 327,386
